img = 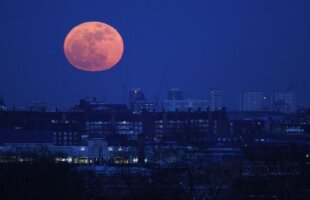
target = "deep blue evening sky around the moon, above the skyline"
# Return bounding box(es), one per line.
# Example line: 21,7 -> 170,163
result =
0,0 -> 310,108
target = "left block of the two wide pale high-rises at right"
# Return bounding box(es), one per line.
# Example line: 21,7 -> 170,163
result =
240,92 -> 269,111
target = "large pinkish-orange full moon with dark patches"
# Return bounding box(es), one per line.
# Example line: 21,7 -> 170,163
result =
64,22 -> 124,72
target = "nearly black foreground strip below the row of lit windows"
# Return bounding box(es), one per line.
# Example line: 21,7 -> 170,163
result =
0,160 -> 310,200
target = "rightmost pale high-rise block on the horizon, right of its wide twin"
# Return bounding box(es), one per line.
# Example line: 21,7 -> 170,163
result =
271,92 -> 296,113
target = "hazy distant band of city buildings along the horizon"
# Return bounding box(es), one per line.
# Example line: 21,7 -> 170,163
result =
0,88 -> 300,113
